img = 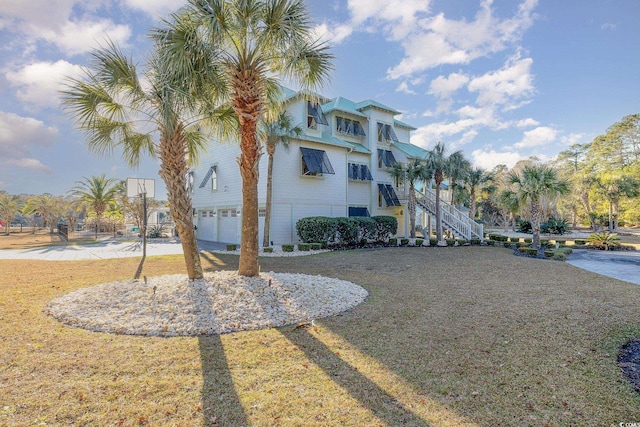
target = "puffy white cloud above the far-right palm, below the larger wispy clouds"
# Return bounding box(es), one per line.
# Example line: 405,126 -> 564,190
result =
468,58 -> 534,106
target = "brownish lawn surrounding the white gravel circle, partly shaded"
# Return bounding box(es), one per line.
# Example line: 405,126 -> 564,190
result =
0,234 -> 640,426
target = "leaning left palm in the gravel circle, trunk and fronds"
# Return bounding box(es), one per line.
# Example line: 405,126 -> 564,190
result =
62,43 -> 205,280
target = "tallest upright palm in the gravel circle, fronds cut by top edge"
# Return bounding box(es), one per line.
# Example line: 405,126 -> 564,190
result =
155,0 -> 333,276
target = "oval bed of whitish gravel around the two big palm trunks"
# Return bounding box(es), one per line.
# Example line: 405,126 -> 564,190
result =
44,271 -> 368,337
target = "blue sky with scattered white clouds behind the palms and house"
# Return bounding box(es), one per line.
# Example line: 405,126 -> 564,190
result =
0,0 -> 640,197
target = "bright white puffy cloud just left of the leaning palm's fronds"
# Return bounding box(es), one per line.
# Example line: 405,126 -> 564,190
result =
5,60 -> 82,108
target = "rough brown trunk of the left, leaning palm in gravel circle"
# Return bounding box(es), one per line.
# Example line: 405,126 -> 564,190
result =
160,125 -> 203,280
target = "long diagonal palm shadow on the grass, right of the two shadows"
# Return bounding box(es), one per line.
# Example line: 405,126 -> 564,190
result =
280,328 -> 429,427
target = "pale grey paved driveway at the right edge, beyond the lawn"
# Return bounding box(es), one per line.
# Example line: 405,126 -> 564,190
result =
567,249 -> 640,285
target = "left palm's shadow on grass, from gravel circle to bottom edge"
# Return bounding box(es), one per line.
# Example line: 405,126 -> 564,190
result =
198,335 -> 248,427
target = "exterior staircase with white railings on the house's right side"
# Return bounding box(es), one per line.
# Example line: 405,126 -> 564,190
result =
415,188 -> 484,240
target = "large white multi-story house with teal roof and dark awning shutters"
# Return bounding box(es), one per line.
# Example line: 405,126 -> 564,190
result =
190,90 -> 427,244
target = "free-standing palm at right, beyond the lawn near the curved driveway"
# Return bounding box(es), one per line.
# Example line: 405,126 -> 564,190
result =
509,164 -> 570,248
